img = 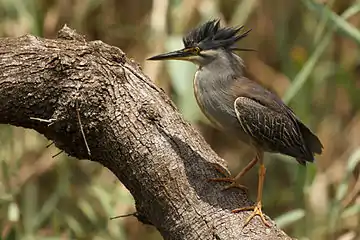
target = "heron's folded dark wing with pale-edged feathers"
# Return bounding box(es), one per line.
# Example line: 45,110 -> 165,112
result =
234,97 -> 313,161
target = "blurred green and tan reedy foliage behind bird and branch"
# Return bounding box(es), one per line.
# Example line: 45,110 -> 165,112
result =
0,0 -> 360,240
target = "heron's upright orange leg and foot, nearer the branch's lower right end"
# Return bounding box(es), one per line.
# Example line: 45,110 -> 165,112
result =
232,153 -> 270,227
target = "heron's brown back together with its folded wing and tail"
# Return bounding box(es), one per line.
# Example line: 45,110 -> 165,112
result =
231,77 -> 322,164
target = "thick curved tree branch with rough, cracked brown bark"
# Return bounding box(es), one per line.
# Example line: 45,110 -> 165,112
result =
0,26 -> 290,240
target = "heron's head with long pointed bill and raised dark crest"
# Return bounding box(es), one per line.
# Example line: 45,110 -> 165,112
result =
147,20 -> 254,65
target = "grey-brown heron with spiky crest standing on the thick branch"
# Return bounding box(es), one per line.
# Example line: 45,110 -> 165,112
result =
147,19 -> 323,227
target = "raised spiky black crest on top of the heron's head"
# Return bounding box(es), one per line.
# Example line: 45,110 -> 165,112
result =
183,19 -> 251,49
